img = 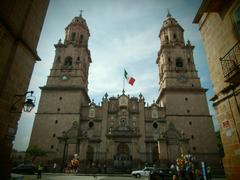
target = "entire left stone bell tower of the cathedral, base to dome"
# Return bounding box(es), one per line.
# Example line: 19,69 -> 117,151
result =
30,14 -> 92,159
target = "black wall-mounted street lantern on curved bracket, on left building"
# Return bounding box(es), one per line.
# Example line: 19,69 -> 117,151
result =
10,91 -> 36,113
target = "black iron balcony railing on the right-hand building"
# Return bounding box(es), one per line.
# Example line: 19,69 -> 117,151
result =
220,42 -> 240,82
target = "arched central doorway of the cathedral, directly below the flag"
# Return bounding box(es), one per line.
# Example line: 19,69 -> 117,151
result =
114,143 -> 132,171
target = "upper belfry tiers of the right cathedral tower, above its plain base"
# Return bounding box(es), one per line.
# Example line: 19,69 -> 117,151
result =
156,12 -> 201,91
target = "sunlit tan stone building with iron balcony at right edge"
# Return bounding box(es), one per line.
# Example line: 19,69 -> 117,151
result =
194,0 -> 240,179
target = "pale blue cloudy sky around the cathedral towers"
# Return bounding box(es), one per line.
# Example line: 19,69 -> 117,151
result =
14,0 -> 219,151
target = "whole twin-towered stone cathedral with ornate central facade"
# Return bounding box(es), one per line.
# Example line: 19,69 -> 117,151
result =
30,12 -> 219,172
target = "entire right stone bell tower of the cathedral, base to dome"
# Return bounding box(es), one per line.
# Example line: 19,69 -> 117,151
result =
156,12 -> 217,163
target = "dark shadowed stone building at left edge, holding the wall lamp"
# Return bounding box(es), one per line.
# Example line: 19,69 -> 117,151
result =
0,0 -> 49,179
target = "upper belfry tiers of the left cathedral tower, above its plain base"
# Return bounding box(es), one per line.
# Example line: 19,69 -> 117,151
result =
47,15 -> 92,94
